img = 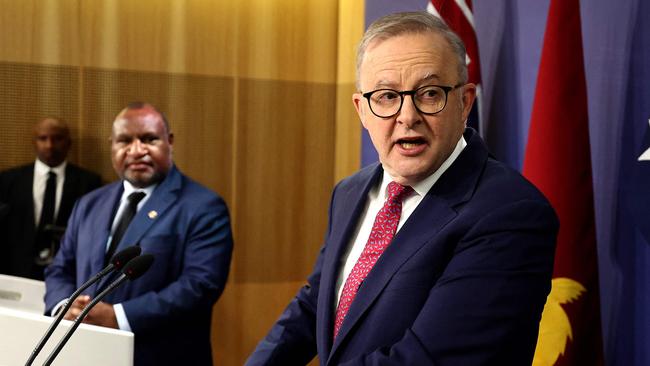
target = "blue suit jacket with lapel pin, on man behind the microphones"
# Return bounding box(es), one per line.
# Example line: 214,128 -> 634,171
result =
45,167 -> 232,365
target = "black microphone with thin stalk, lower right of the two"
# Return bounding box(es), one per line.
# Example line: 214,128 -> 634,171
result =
43,254 -> 153,366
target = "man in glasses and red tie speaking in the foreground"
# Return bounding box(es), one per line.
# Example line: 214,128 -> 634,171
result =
247,13 -> 558,365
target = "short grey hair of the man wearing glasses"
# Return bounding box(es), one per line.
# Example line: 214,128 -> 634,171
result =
357,11 -> 467,90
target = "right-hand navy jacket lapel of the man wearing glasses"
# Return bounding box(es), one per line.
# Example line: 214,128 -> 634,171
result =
330,128 -> 487,361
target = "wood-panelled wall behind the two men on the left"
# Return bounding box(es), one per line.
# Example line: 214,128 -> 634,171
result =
0,0 -> 364,365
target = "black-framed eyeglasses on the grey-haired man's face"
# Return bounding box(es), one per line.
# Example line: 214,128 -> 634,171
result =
362,84 -> 465,118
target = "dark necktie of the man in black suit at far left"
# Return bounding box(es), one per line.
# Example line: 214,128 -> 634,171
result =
32,171 -> 56,272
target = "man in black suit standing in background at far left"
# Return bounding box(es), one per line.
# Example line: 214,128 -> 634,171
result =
0,117 -> 102,280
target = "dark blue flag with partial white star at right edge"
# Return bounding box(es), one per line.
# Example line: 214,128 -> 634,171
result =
610,1 -> 650,365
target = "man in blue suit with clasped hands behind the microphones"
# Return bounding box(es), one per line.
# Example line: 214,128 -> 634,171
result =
45,103 -> 232,365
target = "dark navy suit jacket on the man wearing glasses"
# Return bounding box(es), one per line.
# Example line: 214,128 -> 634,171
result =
247,128 -> 558,366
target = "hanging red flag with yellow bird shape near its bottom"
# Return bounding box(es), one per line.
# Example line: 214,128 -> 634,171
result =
523,0 -> 602,365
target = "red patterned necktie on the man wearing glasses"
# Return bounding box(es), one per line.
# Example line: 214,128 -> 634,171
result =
334,182 -> 413,338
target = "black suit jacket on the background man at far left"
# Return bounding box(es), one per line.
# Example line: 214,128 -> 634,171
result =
0,163 -> 101,279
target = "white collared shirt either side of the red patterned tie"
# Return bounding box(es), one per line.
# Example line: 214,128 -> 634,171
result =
334,136 -> 467,309
